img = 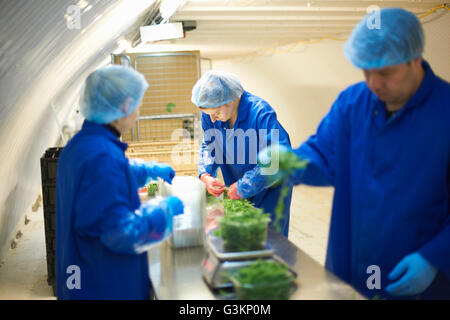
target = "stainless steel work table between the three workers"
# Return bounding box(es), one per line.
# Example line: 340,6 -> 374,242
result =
148,228 -> 365,300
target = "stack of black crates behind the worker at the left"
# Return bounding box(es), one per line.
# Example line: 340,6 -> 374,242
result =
41,148 -> 63,294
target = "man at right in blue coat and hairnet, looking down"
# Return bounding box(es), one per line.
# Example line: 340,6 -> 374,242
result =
259,8 -> 450,299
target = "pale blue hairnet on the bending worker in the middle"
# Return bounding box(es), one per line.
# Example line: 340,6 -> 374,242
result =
191,70 -> 244,108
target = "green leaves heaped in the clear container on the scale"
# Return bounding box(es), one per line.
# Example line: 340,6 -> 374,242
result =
214,199 -> 270,252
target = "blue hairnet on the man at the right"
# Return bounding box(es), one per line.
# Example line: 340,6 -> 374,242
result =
344,8 -> 424,69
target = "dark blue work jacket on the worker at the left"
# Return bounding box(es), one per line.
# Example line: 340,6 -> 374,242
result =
56,120 -> 150,299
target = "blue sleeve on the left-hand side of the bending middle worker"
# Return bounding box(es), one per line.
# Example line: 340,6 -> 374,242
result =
198,113 -> 223,177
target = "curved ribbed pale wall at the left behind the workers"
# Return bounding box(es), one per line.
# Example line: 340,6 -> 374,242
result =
0,0 -> 153,260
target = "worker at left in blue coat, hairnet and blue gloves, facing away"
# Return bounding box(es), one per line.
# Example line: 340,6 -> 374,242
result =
56,66 -> 183,299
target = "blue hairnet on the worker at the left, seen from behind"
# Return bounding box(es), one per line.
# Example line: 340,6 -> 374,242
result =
80,66 -> 148,124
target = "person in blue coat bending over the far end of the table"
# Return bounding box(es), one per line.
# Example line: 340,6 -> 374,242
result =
192,70 -> 292,237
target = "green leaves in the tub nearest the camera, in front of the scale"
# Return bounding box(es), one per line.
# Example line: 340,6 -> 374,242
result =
231,260 -> 294,300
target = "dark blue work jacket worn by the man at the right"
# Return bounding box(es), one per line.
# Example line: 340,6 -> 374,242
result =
295,61 -> 450,299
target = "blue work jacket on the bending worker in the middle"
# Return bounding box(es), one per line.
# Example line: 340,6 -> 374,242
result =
198,91 -> 292,237
